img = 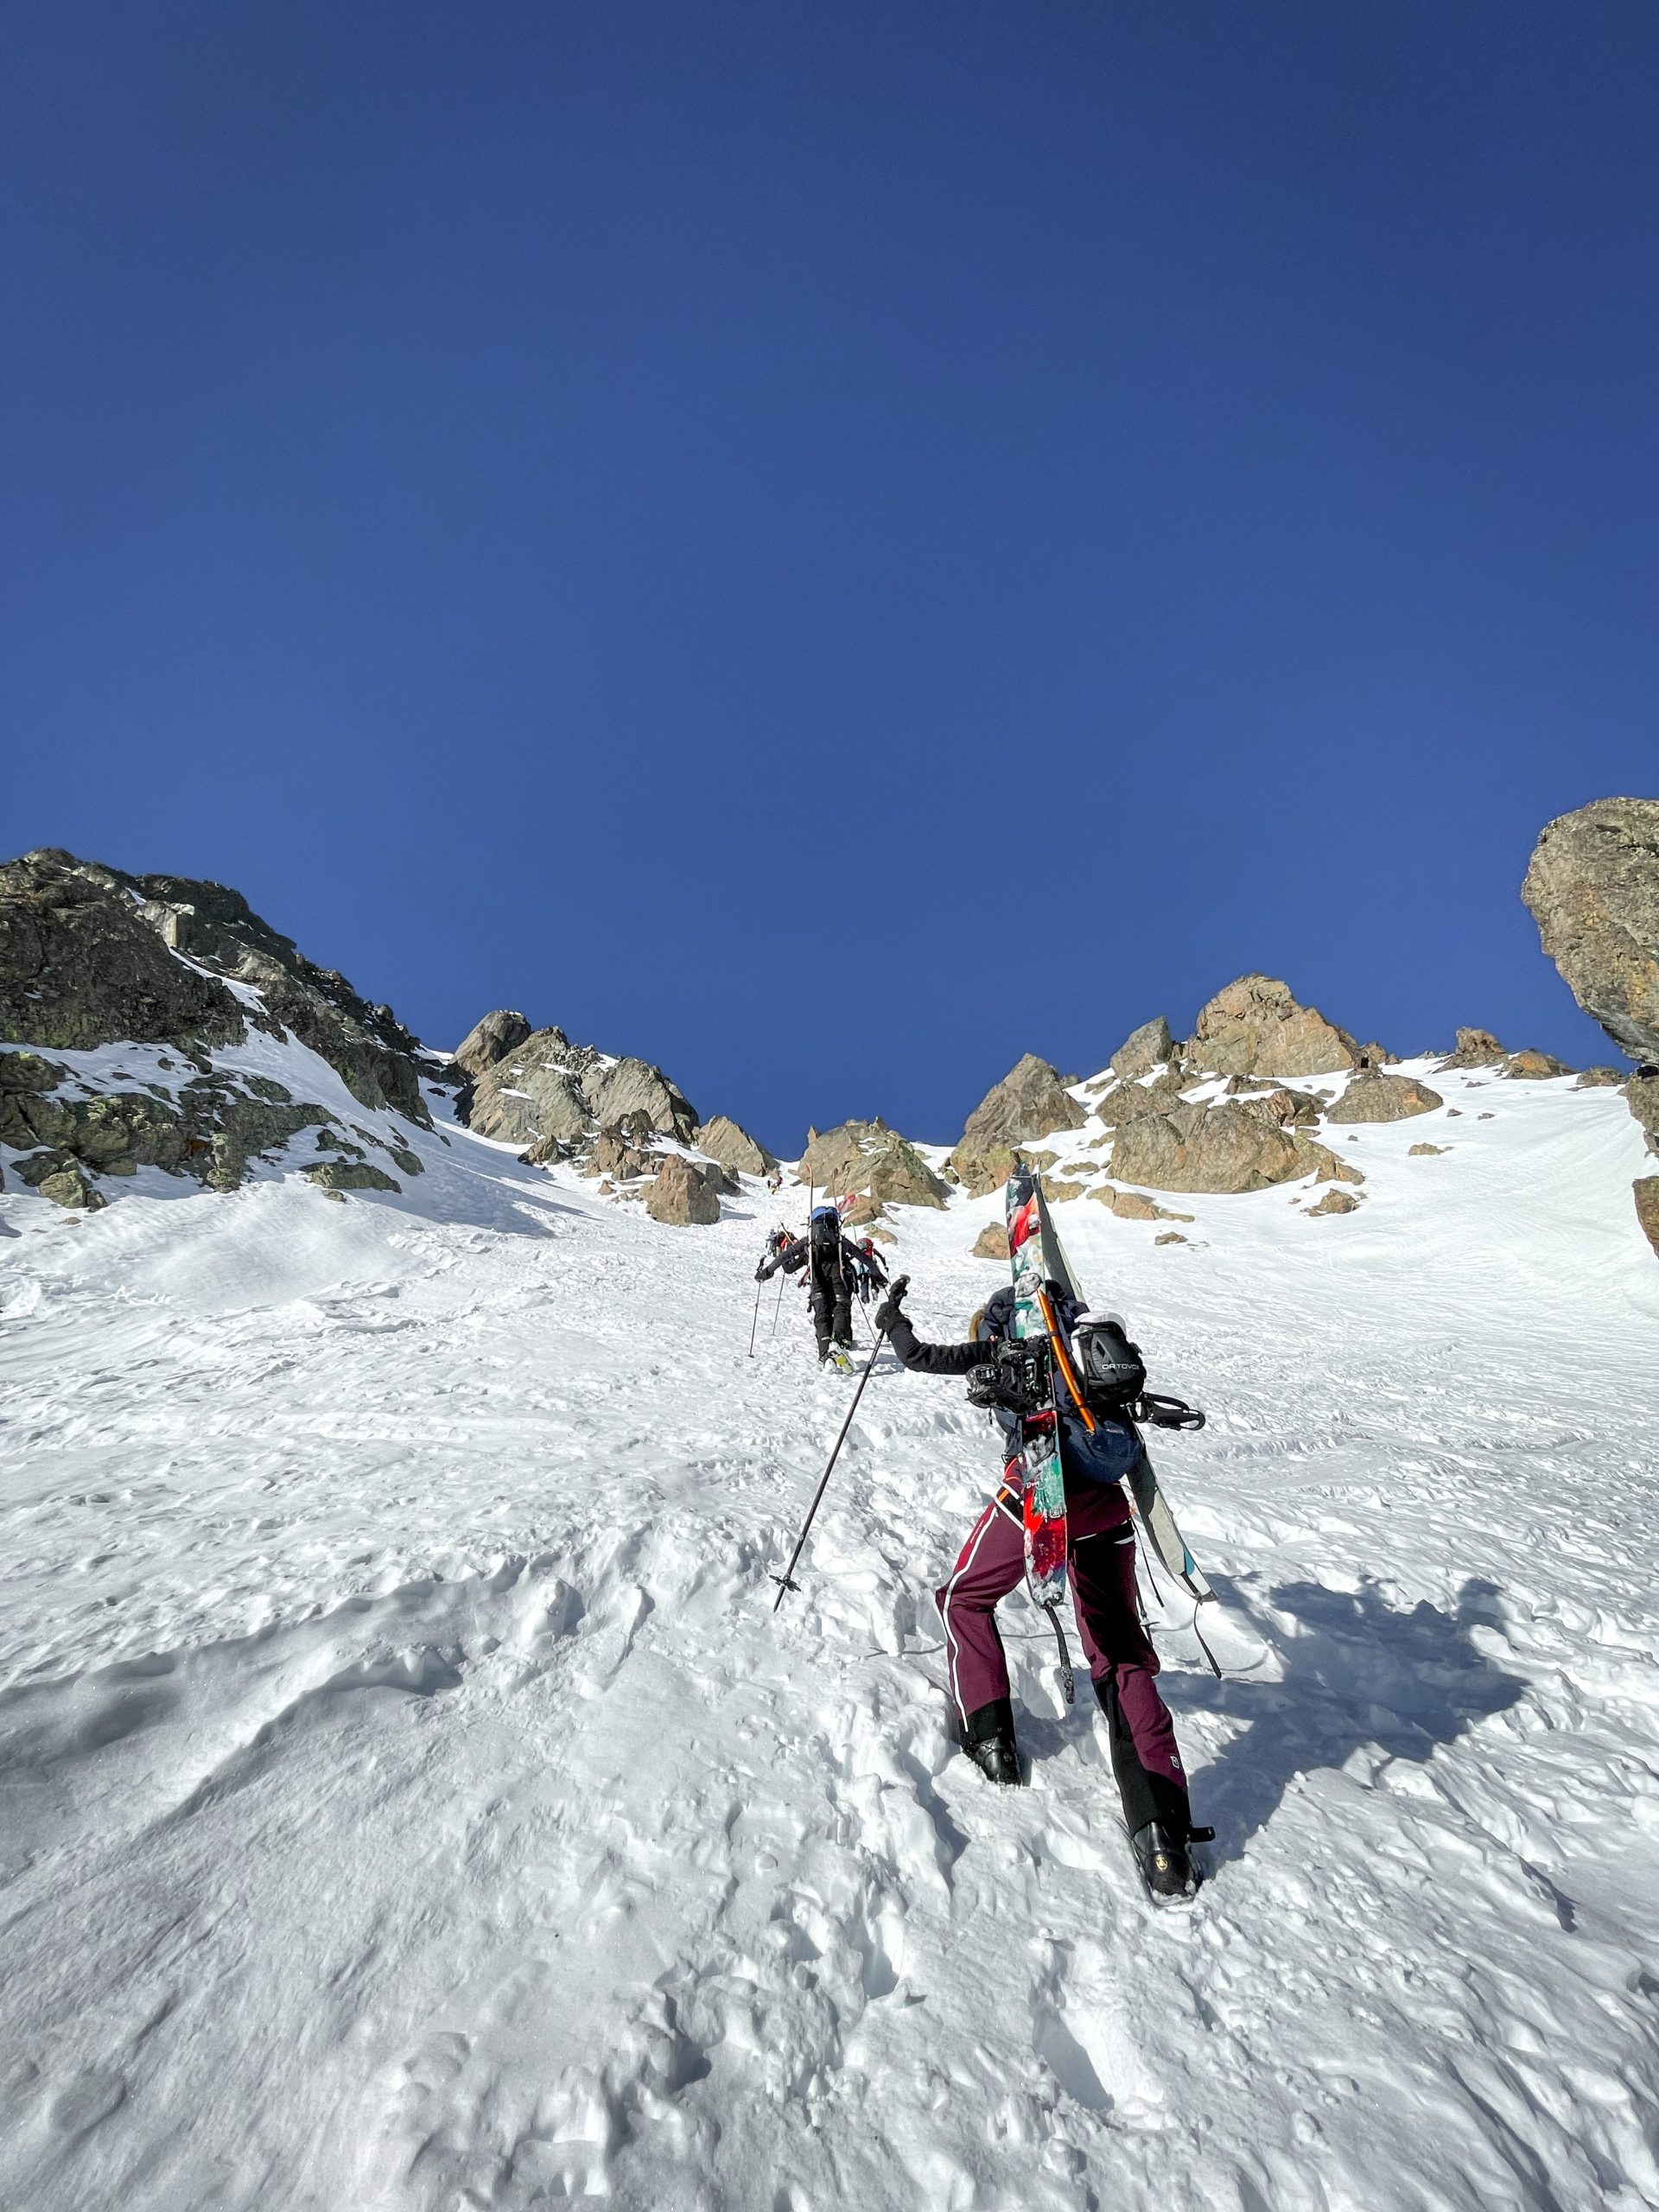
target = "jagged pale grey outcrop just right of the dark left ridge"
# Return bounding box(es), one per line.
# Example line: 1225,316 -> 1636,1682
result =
467,1028 -> 696,1161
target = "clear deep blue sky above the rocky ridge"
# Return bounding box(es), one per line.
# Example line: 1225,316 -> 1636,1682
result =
0,13 -> 1659,1148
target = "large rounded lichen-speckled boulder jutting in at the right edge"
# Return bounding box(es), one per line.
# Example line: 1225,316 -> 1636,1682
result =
1522,798 -> 1659,1062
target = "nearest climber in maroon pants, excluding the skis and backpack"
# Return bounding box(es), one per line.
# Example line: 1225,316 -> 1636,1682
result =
876,1283 -> 1208,1900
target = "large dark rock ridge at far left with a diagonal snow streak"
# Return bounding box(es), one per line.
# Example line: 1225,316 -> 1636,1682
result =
0,849 -> 431,1126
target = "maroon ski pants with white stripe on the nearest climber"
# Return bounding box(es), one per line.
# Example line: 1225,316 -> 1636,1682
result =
936,1482 -> 1188,1829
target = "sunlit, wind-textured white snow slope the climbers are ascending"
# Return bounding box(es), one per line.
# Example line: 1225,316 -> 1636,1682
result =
0,1058 -> 1659,2212
